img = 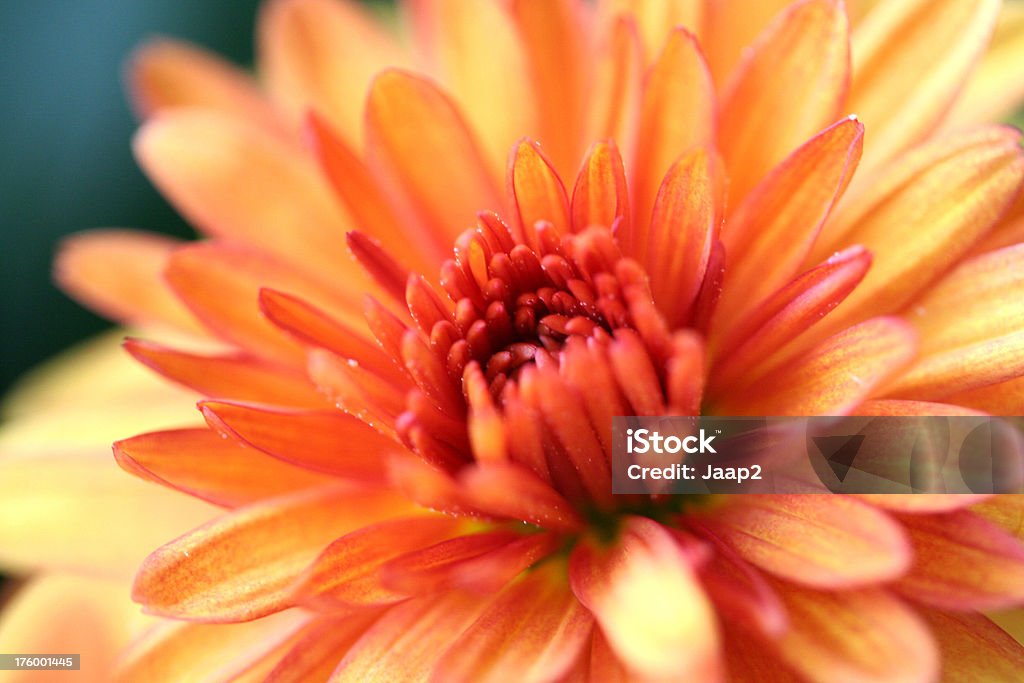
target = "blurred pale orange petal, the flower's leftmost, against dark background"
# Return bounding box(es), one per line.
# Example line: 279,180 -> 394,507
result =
53,230 -> 203,334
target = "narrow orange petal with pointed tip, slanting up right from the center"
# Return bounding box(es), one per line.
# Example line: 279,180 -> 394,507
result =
718,118 -> 864,325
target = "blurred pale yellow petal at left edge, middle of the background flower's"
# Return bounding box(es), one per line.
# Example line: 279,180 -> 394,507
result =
0,444 -> 217,578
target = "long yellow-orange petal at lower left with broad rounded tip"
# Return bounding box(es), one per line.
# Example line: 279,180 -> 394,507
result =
132,486 -> 412,623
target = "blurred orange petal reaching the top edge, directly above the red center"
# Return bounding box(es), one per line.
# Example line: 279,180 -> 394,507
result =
509,0 -> 590,177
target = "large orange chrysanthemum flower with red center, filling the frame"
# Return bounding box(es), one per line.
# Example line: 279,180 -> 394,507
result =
2,0 -> 1024,681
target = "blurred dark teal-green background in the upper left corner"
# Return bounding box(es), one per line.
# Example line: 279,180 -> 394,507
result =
0,0 -> 259,390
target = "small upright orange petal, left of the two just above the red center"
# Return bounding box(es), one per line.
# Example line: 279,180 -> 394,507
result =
508,140 -> 570,248
